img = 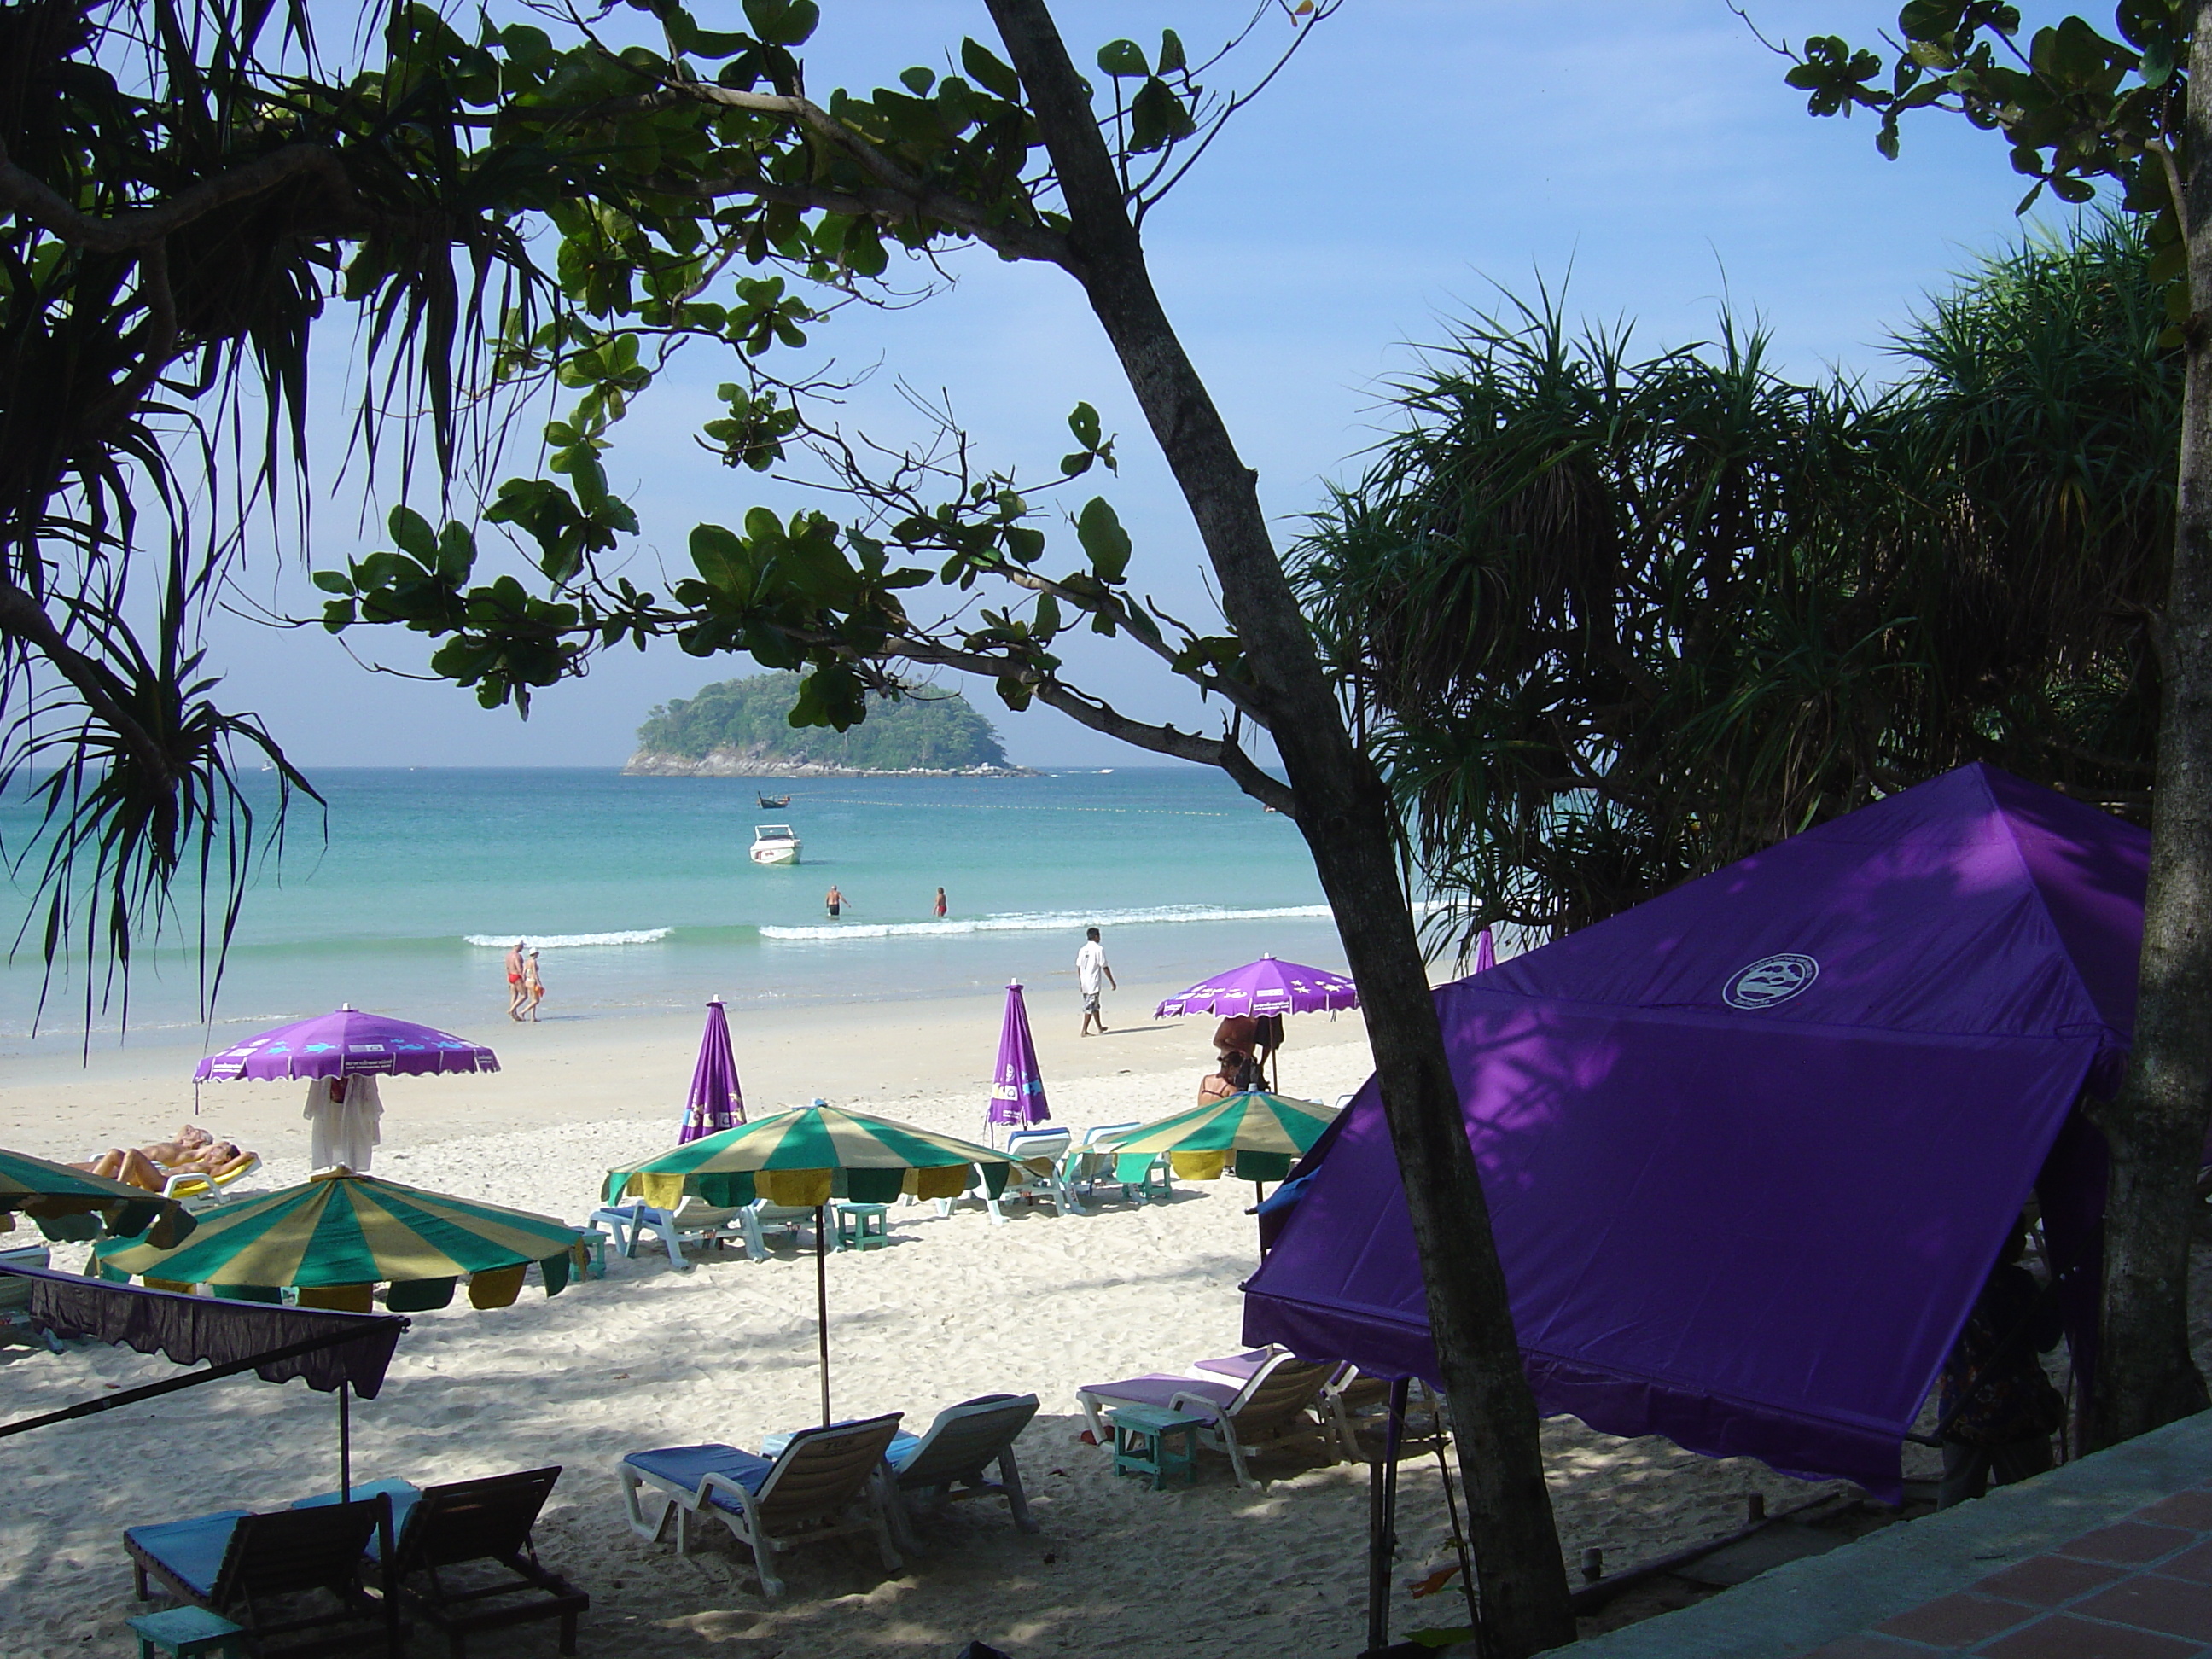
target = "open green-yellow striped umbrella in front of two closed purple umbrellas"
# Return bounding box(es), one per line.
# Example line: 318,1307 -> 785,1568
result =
606,1102 -> 1013,1210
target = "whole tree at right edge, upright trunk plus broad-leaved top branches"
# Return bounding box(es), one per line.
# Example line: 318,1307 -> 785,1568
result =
1787,0 -> 2212,1442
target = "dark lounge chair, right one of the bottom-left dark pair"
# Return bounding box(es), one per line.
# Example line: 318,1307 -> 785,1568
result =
292,1464 -> 591,1659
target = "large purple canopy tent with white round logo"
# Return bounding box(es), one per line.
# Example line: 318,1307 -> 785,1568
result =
1245,765 -> 2150,1499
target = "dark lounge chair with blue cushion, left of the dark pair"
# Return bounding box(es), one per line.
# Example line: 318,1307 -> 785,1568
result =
124,1491 -> 407,1659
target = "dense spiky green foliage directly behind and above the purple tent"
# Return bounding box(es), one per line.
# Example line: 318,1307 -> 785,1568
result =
1296,221 -> 2179,942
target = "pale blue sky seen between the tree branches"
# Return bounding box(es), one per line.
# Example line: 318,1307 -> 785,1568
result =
212,0 -> 2052,765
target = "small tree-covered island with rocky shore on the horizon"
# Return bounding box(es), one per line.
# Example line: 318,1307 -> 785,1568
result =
621,675 -> 1035,778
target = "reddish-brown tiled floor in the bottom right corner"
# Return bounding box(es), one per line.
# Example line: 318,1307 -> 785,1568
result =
1805,1482 -> 2212,1659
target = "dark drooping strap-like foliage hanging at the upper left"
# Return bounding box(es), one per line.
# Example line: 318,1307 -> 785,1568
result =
0,0 -> 557,1026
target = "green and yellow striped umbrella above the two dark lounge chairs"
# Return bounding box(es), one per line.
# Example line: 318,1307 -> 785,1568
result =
95,1170 -> 579,1314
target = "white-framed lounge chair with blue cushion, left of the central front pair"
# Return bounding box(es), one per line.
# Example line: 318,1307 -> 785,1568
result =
615,1412 -> 900,1602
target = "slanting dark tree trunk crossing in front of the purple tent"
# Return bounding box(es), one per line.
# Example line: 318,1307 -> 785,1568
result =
989,0 -> 1575,1659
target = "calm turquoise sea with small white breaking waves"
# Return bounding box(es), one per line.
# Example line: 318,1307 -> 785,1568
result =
0,767 -> 1342,1053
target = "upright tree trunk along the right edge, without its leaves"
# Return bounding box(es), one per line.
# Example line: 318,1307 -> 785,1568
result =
2090,0 -> 2212,1447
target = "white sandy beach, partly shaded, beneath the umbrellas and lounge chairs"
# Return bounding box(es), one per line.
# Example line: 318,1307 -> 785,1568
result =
0,1008 -> 1884,1659
